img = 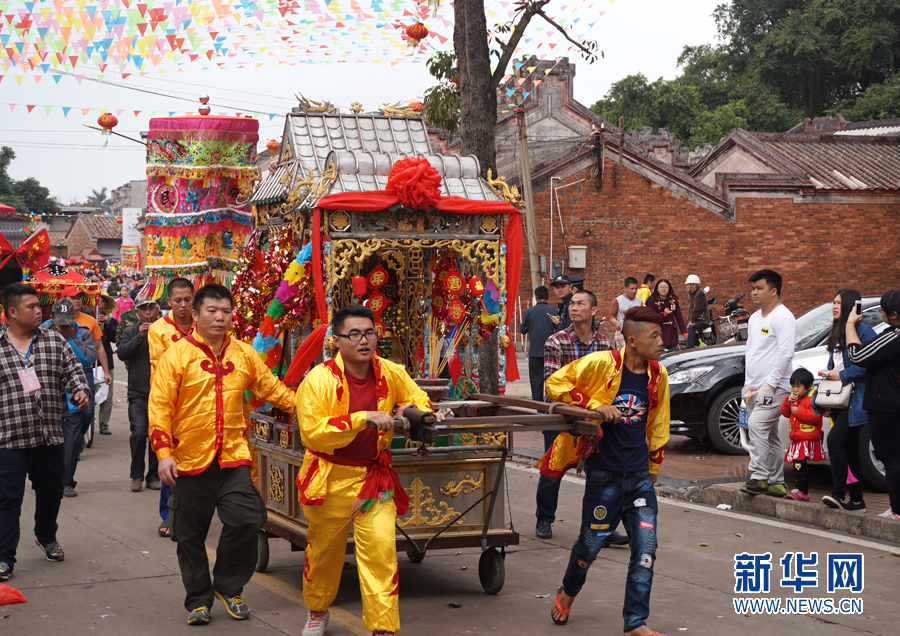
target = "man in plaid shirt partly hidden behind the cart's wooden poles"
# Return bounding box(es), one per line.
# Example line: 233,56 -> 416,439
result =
534,291 -> 609,539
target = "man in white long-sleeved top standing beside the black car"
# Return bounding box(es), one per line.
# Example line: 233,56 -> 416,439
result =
741,269 -> 797,497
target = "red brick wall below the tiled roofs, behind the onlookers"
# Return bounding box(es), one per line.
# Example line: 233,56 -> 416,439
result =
519,160 -> 900,328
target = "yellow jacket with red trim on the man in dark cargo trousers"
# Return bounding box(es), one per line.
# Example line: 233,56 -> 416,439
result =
149,333 -> 296,475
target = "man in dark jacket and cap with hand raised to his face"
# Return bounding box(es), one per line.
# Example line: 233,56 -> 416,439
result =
117,298 -> 160,492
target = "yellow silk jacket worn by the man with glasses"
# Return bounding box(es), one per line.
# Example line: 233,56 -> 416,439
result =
297,354 -> 432,504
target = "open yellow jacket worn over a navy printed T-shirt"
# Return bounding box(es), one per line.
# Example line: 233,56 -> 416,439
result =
538,349 -> 669,477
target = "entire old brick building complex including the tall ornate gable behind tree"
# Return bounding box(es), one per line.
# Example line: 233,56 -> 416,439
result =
430,58 -> 900,320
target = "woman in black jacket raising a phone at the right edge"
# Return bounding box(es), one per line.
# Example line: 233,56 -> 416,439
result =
847,289 -> 900,521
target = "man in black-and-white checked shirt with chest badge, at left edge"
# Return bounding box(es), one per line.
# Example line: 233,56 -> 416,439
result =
0,283 -> 88,581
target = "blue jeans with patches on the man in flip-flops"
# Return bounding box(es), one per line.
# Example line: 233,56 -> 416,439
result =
563,467 -> 657,632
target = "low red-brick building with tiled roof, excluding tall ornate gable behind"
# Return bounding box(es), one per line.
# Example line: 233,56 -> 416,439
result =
521,129 -> 900,313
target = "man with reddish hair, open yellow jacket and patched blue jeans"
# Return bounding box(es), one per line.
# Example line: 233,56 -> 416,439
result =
546,307 -> 669,636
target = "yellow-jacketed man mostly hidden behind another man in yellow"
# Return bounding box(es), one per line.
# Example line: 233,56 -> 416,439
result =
147,278 -> 195,537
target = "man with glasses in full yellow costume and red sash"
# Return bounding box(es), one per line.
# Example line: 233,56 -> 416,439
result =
297,305 -> 443,636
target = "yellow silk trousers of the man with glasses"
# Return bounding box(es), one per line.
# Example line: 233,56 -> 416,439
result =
303,465 -> 400,632
